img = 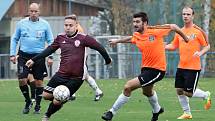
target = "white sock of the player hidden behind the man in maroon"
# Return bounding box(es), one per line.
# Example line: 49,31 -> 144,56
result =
86,76 -> 102,95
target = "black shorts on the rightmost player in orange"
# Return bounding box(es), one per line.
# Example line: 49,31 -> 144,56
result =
175,68 -> 201,93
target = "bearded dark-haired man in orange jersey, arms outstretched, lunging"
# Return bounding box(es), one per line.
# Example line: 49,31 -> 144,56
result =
102,12 -> 187,121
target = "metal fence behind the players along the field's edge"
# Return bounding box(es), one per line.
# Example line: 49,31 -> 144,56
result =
0,36 -> 215,79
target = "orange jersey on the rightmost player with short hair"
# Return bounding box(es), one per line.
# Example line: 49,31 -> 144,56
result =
172,27 -> 208,70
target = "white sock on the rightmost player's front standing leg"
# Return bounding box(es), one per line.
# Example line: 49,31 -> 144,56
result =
178,95 -> 191,114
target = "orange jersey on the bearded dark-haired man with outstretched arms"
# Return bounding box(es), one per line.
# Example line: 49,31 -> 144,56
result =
131,29 -> 170,71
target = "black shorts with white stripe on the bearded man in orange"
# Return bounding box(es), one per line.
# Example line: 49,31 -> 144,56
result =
138,67 -> 165,87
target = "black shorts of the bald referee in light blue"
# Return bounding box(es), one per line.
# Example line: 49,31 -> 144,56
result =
17,51 -> 47,80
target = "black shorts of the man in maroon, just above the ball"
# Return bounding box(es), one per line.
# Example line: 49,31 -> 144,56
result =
44,74 -> 84,96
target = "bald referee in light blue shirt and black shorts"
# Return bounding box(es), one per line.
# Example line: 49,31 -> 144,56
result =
10,3 -> 54,114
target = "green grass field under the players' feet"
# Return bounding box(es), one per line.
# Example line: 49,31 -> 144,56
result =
0,78 -> 215,121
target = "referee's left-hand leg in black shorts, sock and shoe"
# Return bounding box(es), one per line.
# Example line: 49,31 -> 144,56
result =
17,54 -> 32,114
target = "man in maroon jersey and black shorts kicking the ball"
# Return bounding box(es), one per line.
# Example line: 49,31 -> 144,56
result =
26,16 -> 111,121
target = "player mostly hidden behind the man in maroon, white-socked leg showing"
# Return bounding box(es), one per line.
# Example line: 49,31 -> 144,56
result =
70,14 -> 103,101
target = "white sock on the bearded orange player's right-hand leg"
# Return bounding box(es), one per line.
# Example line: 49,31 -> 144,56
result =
148,91 -> 161,113
